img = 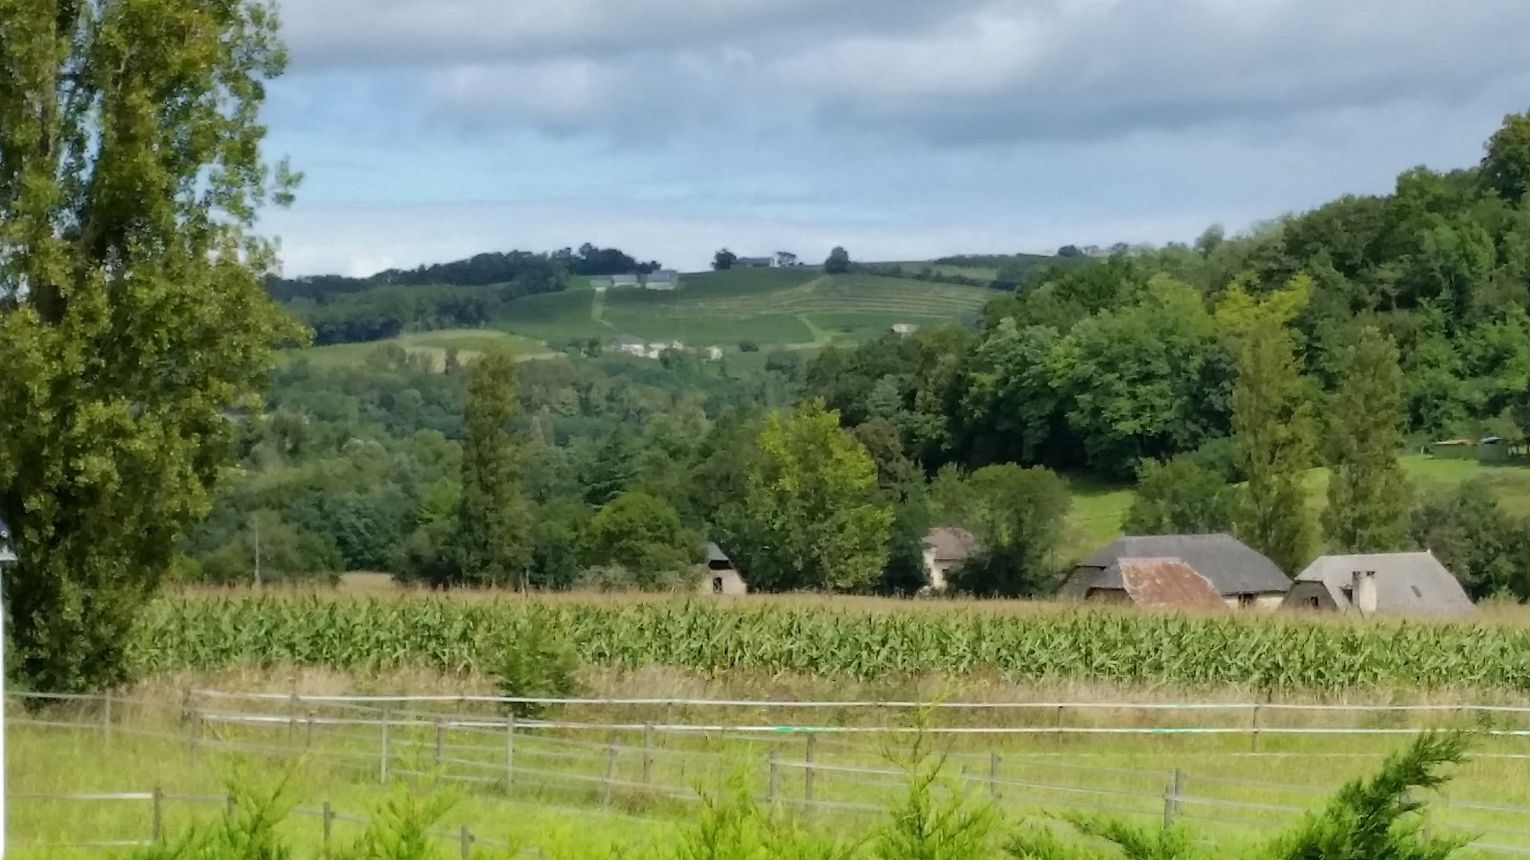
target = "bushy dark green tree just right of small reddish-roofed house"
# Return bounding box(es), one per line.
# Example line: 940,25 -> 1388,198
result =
952,464 -> 1073,597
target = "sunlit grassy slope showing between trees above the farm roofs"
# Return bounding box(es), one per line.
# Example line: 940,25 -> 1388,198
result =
1059,454 -> 1530,562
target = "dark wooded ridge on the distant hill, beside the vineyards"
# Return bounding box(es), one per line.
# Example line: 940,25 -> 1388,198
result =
275,243 -> 659,346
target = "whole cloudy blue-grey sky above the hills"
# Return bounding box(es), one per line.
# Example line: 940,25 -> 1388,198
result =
260,0 -> 1530,275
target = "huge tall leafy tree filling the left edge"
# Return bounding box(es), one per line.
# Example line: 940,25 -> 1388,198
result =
0,0 -> 300,692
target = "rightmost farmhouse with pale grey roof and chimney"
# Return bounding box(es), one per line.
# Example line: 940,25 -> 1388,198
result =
1285,552 -> 1476,617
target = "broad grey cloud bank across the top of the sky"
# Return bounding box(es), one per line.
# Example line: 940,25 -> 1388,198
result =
286,0 -> 1530,145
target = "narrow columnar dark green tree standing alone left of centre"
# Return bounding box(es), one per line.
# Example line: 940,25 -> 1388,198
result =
456,352 -> 531,586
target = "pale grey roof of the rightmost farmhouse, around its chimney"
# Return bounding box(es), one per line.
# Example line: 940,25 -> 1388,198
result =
1296,552 -> 1476,615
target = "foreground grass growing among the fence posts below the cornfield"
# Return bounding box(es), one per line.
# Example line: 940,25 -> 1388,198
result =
8,697 -> 1530,858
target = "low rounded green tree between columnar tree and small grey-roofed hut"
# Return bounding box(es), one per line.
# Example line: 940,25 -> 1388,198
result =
588,493 -> 701,588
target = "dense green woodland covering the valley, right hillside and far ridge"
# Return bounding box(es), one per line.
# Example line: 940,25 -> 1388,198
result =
185,110 -> 1530,598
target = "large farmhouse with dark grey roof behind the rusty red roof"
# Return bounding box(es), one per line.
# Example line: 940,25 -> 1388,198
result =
1057,534 -> 1291,609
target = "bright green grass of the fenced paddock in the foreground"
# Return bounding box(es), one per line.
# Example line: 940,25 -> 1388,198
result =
8,696 -> 1530,860
